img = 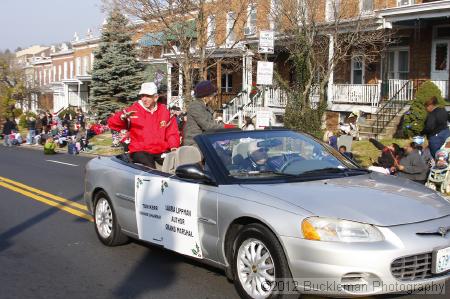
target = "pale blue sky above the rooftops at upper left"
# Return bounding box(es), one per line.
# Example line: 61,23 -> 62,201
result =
0,0 -> 105,51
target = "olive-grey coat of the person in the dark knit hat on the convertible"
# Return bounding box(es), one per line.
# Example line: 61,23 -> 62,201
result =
183,99 -> 223,145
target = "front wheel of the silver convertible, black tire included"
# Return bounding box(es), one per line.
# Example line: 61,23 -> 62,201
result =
232,223 -> 298,298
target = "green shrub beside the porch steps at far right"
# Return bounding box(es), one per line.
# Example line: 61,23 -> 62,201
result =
403,81 -> 445,137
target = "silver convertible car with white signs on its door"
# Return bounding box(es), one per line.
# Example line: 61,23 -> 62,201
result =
84,129 -> 450,298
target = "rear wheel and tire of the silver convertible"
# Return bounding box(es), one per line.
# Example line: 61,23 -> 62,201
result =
94,191 -> 128,246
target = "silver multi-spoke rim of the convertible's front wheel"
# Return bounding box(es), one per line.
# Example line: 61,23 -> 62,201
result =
237,239 -> 275,298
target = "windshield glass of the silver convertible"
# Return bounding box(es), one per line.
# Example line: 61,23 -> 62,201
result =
208,130 -> 361,179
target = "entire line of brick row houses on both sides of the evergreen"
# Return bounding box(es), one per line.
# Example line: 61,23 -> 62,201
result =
14,0 -> 450,130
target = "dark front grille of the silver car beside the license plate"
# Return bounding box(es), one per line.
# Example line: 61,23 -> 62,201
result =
391,252 -> 445,281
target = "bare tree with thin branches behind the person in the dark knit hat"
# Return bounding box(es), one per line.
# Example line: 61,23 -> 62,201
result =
107,0 -> 249,103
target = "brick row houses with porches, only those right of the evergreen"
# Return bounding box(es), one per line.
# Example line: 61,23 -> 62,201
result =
134,0 -> 450,131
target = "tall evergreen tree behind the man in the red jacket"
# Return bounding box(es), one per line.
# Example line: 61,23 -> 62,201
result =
90,9 -> 143,119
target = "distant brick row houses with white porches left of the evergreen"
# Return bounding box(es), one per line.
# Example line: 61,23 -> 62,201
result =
16,31 -> 100,112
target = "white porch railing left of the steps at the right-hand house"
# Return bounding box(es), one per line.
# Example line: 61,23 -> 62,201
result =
332,84 -> 380,107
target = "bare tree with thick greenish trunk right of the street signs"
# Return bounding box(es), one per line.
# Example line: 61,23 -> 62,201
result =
271,0 -> 391,136
